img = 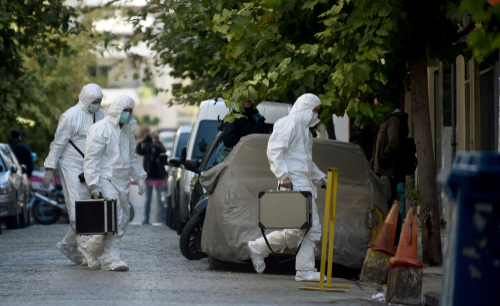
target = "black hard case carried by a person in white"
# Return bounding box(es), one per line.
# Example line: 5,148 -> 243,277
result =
75,199 -> 118,235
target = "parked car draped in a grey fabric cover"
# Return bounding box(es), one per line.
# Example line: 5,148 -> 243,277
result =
200,134 -> 390,269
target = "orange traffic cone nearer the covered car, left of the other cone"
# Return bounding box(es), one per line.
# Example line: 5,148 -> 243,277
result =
368,200 -> 401,255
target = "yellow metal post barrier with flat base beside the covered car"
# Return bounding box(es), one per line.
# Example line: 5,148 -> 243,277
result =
299,168 -> 351,292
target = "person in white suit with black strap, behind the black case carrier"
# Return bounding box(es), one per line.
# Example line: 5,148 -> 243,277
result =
43,84 -> 105,264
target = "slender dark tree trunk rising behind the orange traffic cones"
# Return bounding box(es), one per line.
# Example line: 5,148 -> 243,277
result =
409,40 -> 443,266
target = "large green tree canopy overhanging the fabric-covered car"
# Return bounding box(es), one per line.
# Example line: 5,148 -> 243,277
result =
125,0 -> 467,124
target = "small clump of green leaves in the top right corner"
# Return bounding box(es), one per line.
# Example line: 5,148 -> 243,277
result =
461,0 -> 500,58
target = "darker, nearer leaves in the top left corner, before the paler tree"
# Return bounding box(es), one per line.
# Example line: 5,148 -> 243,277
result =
0,0 -> 81,126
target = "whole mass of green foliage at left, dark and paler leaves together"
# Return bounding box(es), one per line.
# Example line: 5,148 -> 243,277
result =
0,0 -> 108,163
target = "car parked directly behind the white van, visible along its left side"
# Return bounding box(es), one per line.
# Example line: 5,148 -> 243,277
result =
165,125 -> 192,229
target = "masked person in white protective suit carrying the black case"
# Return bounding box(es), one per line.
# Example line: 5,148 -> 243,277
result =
79,96 -> 146,271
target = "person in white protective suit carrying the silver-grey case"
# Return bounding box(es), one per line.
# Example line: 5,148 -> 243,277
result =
248,94 -> 326,281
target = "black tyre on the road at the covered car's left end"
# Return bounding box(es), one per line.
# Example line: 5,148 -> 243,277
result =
179,213 -> 207,260
